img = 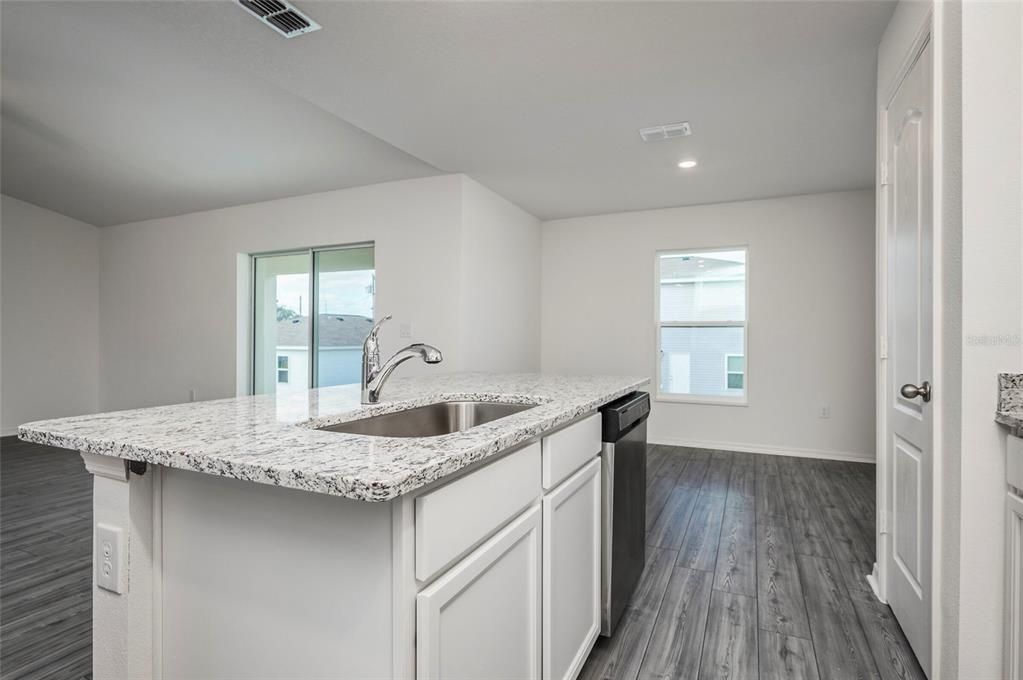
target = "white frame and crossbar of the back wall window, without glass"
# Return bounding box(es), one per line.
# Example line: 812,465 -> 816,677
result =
654,243 -> 751,406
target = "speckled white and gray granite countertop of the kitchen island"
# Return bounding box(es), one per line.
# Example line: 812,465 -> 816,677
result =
18,373 -> 649,501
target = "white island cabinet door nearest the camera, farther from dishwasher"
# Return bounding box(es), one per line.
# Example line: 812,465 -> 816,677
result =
415,506 -> 540,680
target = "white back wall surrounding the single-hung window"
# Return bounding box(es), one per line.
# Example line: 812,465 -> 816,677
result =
541,190 -> 875,460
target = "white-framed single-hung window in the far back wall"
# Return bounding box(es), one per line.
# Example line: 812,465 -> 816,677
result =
656,247 -> 748,405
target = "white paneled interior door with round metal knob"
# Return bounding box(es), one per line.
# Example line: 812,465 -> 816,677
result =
885,42 -> 934,675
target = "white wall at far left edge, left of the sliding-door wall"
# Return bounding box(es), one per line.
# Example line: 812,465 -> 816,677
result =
0,196 -> 99,435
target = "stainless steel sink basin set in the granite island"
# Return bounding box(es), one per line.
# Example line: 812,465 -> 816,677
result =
316,402 -> 536,437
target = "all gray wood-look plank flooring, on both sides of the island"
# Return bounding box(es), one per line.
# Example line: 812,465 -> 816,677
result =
0,438 -> 924,680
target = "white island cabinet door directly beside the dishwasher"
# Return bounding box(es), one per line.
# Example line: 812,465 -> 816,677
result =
543,458 -> 601,680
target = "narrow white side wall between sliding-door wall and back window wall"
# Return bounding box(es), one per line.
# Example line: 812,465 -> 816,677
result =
460,177 -> 540,372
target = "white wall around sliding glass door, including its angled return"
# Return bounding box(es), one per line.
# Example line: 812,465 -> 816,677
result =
100,175 -> 538,410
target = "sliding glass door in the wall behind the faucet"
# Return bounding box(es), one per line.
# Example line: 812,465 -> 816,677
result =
253,245 -> 376,394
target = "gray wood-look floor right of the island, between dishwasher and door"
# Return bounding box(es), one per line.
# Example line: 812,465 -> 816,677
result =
581,446 -> 925,680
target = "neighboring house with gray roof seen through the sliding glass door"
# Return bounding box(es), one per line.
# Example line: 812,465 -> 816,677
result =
276,314 -> 372,392
